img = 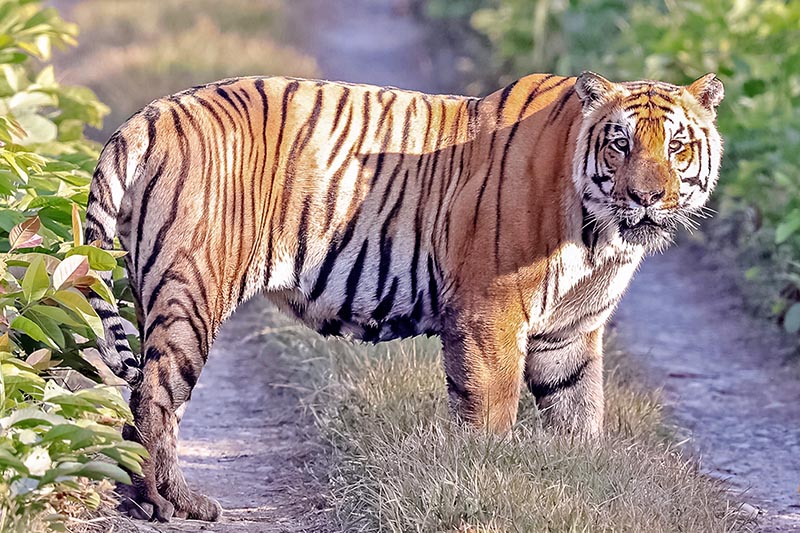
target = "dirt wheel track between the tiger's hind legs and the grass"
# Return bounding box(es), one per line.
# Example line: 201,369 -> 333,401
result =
125,298 -> 327,533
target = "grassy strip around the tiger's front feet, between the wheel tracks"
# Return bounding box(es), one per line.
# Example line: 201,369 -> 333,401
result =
262,308 -> 751,532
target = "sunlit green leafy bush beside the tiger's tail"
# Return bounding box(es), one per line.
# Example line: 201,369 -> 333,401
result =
0,0 -> 146,531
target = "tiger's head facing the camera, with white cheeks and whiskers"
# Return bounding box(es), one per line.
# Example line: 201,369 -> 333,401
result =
573,72 -> 724,251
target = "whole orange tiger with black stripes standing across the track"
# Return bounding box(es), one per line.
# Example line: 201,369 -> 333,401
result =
85,72 -> 724,521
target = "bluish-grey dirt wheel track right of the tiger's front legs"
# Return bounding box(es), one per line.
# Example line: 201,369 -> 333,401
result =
614,246 -> 800,531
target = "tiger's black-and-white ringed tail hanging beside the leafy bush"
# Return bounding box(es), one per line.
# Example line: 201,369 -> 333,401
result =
84,132 -> 143,388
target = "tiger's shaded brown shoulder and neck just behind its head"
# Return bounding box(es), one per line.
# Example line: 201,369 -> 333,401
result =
434,75 -> 641,318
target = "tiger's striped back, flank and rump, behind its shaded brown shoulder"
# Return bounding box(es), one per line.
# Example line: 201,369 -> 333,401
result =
101,78 -> 494,340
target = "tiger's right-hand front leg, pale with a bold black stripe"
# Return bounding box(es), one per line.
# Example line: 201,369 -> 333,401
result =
525,327 -> 604,437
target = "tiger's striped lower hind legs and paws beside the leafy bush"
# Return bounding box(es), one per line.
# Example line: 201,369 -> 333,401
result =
124,282 -> 222,521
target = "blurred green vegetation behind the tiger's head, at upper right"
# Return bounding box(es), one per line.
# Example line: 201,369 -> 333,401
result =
428,0 -> 800,332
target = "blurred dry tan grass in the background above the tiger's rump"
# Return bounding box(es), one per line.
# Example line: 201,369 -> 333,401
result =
58,0 -> 317,141
